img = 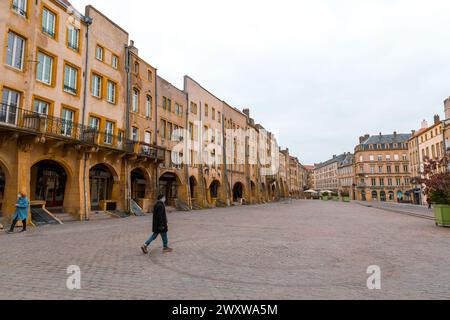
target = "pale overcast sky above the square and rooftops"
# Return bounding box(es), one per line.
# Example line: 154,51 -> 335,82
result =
70,0 -> 450,164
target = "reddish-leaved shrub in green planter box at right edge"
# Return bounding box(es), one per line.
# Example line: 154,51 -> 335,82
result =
421,155 -> 450,227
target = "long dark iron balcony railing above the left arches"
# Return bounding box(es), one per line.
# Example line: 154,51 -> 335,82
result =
0,103 -> 165,161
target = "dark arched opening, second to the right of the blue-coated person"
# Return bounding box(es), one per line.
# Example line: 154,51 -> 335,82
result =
89,164 -> 114,210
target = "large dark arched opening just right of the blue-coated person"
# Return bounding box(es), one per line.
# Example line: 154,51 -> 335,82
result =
30,160 -> 68,208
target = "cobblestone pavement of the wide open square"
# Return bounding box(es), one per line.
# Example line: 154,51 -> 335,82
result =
0,201 -> 450,300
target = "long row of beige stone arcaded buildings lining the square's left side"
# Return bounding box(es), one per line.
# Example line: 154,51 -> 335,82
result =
0,0 -> 305,225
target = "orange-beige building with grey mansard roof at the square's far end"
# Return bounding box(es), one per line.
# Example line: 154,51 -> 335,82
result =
355,132 -> 413,202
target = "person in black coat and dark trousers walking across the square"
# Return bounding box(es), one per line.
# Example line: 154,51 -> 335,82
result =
141,195 -> 173,254
